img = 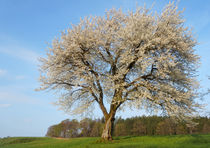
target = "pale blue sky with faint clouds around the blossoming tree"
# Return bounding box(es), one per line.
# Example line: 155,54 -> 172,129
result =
0,0 -> 210,137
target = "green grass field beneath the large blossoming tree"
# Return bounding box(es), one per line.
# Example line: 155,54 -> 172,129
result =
0,135 -> 210,148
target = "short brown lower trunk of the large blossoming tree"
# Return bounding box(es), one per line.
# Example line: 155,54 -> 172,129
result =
101,113 -> 115,141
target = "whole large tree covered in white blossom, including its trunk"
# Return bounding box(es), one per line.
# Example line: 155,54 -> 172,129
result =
37,3 -> 199,140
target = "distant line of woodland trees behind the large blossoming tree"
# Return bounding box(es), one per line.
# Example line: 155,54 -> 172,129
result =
46,116 -> 210,138
